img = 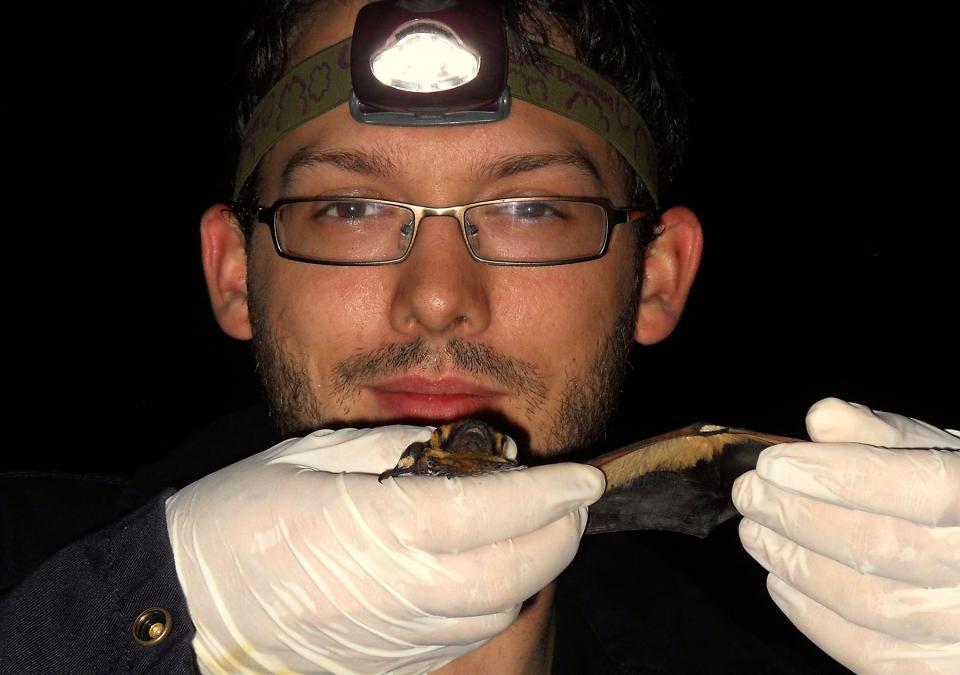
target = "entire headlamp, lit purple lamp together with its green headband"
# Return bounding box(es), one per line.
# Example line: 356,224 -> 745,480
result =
234,0 -> 657,205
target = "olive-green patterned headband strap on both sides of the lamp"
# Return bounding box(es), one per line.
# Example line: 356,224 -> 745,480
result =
233,38 -> 658,204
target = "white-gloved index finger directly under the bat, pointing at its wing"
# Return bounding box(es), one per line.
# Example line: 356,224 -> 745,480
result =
368,463 -> 605,553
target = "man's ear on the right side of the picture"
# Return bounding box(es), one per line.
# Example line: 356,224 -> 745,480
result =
634,206 -> 703,345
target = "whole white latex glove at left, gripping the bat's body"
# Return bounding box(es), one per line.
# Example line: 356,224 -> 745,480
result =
167,426 -> 604,673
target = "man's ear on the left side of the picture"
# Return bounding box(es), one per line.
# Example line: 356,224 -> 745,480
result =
200,204 -> 253,340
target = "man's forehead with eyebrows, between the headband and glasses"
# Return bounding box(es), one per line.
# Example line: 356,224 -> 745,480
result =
263,101 -> 622,200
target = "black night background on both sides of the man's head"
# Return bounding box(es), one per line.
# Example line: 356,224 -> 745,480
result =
0,2 -> 960,473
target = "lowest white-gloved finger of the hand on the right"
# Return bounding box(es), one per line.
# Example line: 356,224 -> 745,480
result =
767,574 -> 960,675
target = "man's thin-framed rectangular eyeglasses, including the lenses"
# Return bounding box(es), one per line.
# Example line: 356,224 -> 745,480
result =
244,197 -> 654,266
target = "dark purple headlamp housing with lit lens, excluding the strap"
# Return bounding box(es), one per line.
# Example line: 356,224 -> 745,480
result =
350,0 -> 510,126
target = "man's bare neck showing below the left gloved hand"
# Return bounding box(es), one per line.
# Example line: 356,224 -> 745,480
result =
434,581 -> 557,675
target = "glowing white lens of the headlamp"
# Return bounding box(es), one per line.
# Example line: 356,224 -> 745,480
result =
370,21 -> 480,92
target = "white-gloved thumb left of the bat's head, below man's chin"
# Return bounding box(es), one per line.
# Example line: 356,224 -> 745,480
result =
259,424 -> 433,474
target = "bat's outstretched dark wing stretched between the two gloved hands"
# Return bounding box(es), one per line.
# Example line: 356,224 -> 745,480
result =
586,423 -> 797,538
